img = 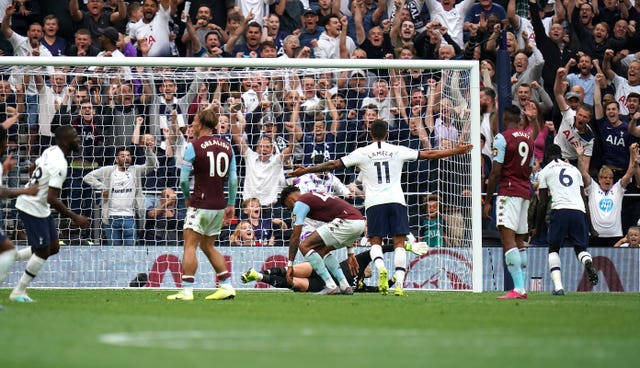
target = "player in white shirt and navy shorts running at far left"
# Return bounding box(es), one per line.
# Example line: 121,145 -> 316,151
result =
9,125 -> 89,302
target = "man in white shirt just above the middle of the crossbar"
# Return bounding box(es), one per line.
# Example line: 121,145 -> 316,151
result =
314,15 -> 356,59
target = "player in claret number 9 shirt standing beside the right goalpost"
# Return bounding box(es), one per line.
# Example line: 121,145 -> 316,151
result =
484,105 -> 533,299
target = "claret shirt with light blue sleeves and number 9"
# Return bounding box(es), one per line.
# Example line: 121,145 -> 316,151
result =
493,128 -> 533,199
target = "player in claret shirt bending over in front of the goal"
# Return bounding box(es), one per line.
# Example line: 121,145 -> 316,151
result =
280,185 -> 365,295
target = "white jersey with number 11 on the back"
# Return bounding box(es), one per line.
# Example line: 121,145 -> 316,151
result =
341,142 -> 419,208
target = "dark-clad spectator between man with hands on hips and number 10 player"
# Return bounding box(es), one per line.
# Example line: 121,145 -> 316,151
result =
144,188 -> 184,245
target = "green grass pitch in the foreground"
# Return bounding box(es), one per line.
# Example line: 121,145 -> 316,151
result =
0,289 -> 640,368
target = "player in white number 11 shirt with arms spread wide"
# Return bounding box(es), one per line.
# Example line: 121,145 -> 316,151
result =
289,119 -> 473,296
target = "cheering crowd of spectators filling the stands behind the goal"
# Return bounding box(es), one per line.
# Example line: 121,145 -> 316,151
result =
0,0 -> 640,246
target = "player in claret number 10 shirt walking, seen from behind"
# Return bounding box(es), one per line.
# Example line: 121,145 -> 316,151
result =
167,110 -> 238,300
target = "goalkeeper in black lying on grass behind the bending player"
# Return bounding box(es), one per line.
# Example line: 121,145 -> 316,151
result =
241,242 -> 429,293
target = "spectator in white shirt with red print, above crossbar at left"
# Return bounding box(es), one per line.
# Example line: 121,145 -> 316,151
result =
129,0 -> 176,56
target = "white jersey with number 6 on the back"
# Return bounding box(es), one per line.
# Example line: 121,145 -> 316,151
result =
538,160 -> 585,212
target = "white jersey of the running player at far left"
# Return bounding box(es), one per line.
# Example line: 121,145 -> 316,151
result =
16,146 -> 69,218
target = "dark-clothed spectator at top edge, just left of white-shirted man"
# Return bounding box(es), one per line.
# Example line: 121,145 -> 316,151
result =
69,0 -> 127,45
